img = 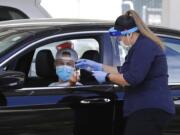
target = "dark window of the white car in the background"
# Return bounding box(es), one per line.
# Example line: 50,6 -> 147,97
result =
0,6 -> 28,21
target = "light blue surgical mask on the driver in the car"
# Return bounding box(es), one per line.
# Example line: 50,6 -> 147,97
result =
56,65 -> 74,82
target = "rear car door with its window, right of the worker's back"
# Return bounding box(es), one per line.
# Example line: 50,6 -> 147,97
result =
161,35 -> 180,134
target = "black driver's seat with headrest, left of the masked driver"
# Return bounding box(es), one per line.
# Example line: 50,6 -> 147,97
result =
30,49 -> 58,86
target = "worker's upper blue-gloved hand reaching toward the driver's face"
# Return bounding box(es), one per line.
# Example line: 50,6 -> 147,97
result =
76,59 -> 102,71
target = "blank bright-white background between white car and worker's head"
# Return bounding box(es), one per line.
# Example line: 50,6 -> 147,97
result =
42,0 -> 122,20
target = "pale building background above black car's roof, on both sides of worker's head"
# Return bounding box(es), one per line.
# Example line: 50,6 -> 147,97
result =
40,0 -> 180,29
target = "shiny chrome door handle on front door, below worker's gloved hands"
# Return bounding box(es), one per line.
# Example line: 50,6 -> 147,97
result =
80,98 -> 111,104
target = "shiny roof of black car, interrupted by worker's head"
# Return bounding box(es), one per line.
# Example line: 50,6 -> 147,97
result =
0,18 -> 180,38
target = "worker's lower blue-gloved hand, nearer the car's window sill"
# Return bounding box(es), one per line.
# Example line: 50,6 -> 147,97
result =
92,71 -> 107,84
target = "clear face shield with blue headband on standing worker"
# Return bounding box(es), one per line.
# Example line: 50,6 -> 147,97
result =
109,27 -> 138,66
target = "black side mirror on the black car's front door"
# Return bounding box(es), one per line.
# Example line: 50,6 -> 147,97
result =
0,71 -> 25,90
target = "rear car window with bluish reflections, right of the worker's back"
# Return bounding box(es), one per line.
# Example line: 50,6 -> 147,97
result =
163,38 -> 180,83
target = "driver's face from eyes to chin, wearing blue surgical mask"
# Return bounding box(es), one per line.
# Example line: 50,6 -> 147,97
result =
56,59 -> 75,82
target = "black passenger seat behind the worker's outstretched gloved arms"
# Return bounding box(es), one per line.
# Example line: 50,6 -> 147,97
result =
80,50 -> 100,85
